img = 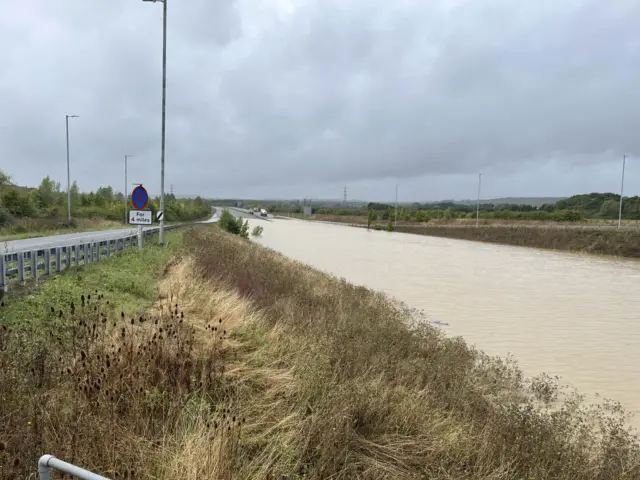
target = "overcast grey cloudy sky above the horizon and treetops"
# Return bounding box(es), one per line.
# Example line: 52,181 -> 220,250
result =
0,0 -> 640,200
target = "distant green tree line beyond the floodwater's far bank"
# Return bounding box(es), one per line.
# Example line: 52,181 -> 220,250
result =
252,193 -> 640,222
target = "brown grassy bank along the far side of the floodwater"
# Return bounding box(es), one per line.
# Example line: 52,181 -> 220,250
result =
395,225 -> 640,258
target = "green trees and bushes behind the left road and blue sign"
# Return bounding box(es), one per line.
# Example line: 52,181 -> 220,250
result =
0,170 -> 211,227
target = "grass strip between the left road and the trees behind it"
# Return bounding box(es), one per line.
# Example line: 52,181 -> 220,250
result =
0,218 -> 125,242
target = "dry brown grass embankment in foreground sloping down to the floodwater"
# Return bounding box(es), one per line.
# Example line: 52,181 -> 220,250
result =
0,226 -> 640,480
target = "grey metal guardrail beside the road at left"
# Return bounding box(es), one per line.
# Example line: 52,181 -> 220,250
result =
0,224 -> 181,292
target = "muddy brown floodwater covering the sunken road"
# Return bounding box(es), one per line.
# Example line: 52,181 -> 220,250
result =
253,220 -> 640,427
